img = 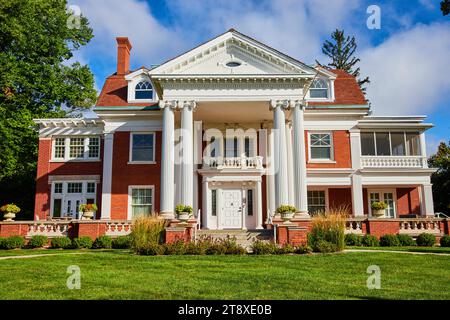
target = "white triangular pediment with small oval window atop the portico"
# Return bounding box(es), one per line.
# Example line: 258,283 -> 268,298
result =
150,30 -> 317,75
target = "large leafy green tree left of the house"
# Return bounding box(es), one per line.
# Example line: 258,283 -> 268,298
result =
0,0 -> 96,218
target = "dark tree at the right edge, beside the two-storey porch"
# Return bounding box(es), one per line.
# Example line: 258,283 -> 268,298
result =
428,141 -> 450,215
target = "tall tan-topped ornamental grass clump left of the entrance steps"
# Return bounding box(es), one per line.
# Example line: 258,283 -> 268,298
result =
130,216 -> 166,253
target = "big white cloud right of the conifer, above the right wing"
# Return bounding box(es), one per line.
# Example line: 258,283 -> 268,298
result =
360,23 -> 450,115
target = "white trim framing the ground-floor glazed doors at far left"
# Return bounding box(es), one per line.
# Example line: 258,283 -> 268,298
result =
49,180 -> 98,217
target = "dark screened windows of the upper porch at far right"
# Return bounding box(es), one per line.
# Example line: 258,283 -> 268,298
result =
361,131 -> 421,156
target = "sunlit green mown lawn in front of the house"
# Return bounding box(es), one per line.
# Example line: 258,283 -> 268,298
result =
0,250 -> 450,299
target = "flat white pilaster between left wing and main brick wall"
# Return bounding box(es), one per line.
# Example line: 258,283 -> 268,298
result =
100,133 -> 114,220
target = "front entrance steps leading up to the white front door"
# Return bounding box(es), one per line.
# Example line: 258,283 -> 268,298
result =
196,229 -> 273,251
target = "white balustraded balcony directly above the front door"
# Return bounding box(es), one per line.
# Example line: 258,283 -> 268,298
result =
203,156 -> 264,170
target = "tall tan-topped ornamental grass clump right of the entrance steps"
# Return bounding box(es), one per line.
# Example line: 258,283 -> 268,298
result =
308,211 -> 345,252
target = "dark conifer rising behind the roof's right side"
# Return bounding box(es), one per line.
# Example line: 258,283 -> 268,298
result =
316,29 -> 370,93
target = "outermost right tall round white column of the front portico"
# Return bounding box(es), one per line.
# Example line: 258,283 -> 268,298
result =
291,101 -> 308,215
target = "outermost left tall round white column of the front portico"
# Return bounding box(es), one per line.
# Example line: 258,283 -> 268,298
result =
159,100 -> 177,219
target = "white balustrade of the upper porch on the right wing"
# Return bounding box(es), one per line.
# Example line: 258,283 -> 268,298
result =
361,156 -> 427,168
